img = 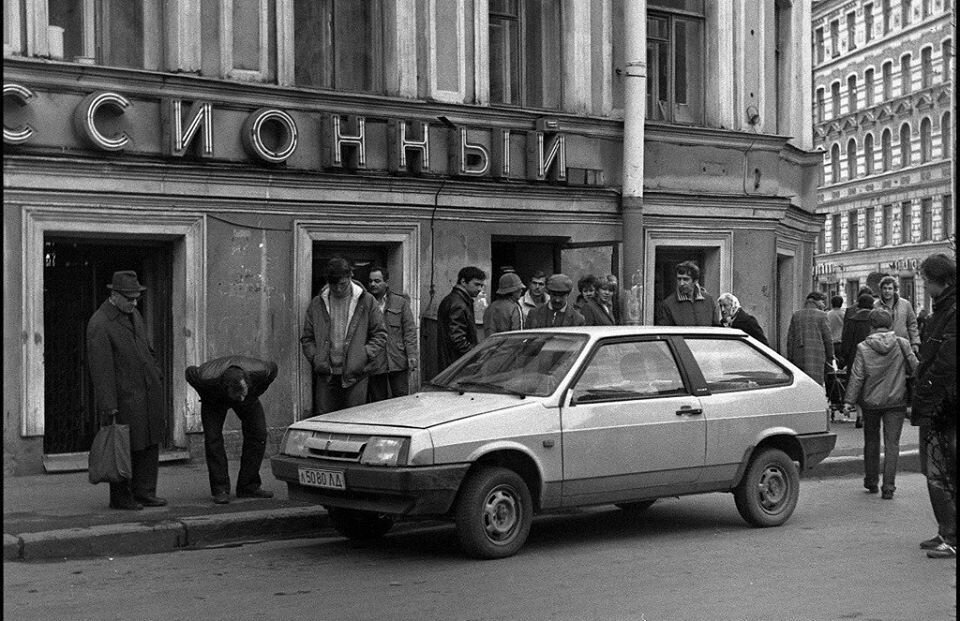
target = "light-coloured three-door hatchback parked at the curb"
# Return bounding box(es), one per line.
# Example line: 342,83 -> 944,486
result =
271,326 -> 836,559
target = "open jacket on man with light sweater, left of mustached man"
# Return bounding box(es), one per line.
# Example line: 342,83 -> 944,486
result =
300,282 -> 387,388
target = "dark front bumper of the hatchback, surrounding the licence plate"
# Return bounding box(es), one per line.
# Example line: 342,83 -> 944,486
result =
270,455 -> 470,515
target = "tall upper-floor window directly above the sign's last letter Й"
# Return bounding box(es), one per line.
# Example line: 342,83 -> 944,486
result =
489,0 -> 562,109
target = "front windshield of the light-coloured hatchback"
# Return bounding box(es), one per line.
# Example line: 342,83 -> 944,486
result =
427,332 -> 587,397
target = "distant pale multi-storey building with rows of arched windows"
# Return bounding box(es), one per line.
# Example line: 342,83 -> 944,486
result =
812,0 -> 956,310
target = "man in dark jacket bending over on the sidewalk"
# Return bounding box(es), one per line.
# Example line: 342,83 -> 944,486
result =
186,356 -> 277,505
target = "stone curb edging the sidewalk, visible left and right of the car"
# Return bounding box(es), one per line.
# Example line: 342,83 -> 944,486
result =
3,449 -> 920,561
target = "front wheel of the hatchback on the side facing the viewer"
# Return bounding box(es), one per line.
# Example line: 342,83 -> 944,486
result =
456,467 -> 533,558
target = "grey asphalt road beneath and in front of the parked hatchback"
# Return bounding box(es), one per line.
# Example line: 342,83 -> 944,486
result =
3,474 -> 956,621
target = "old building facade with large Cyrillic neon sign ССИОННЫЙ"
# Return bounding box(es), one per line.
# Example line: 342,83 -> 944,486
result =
3,0 -> 822,474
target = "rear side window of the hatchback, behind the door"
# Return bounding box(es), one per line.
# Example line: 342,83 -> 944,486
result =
685,337 -> 793,392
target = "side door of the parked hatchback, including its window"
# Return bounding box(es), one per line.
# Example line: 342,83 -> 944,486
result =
561,338 -> 706,505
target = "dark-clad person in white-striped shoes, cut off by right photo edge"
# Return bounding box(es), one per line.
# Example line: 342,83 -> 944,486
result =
910,253 -> 957,558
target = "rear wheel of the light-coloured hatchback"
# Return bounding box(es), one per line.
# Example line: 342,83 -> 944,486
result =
733,449 -> 800,527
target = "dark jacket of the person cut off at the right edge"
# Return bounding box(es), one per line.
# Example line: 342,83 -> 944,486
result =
910,285 -> 957,428
